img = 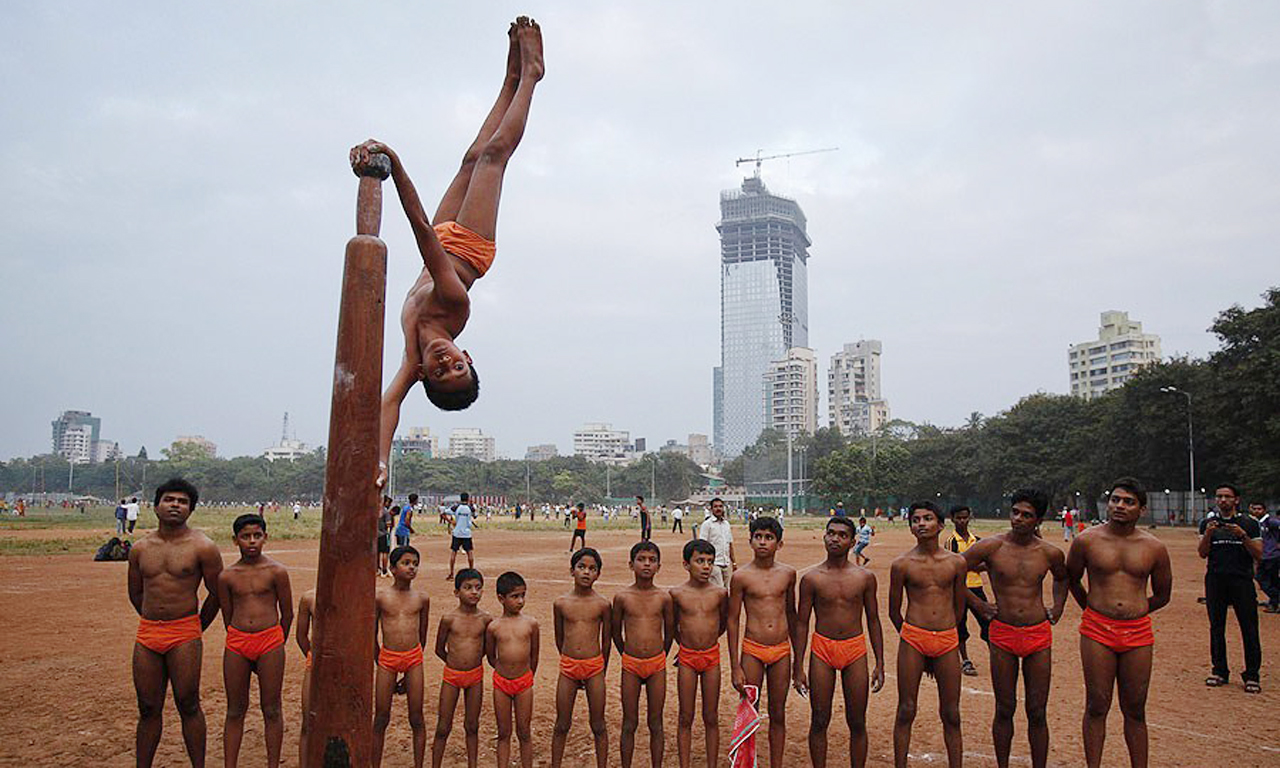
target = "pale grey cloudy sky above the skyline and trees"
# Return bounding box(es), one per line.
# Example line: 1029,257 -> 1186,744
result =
0,0 -> 1280,458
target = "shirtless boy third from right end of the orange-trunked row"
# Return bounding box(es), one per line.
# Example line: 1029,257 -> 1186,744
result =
888,502 -> 969,768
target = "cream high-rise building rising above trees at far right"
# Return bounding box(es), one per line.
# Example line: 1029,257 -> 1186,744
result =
1066,310 -> 1161,399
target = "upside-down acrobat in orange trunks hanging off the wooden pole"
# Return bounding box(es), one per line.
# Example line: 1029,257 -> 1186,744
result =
366,17 -> 545,488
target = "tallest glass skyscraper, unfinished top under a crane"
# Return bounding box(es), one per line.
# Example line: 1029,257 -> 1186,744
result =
713,175 -> 812,458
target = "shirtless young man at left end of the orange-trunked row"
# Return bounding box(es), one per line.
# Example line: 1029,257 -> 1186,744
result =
128,479 -> 223,768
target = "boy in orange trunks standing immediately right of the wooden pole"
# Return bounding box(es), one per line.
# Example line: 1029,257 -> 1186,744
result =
372,547 -> 431,768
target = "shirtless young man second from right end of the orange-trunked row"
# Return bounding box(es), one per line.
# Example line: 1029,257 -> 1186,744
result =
961,490 -> 1068,768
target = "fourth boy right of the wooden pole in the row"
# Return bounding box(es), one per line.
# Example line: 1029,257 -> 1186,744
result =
552,547 -> 613,768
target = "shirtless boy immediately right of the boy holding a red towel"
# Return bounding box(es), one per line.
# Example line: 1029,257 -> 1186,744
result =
794,517 -> 884,768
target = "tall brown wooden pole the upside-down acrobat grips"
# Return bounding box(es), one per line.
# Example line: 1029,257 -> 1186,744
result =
305,155 -> 390,768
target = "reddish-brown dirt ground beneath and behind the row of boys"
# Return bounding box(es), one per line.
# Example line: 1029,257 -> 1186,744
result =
0,519 -> 1280,768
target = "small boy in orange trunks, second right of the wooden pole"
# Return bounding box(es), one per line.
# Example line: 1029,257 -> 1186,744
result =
431,568 -> 493,768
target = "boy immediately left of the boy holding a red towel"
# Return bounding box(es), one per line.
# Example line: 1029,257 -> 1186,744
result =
671,539 -> 728,768
